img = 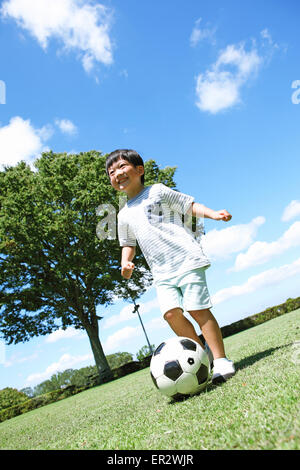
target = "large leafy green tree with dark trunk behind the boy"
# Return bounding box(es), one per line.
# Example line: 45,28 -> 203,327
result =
0,151 -> 175,381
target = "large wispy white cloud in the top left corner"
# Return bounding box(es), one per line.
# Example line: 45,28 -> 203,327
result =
0,0 -> 113,72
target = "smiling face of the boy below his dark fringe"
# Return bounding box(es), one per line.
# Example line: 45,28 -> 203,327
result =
108,158 -> 144,196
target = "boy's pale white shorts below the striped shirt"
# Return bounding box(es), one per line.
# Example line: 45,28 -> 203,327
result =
156,267 -> 212,315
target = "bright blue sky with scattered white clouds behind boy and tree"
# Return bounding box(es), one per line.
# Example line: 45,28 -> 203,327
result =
0,0 -> 300,390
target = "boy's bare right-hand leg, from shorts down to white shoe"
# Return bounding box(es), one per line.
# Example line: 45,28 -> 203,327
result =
189,308 -> 226,359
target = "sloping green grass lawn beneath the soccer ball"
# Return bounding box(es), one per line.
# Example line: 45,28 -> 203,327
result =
0,310 -> 300,450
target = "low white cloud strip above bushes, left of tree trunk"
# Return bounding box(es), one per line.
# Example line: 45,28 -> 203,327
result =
26,354 -> 93,386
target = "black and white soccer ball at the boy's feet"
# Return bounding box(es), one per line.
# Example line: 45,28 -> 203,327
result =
150,336 -> 210,398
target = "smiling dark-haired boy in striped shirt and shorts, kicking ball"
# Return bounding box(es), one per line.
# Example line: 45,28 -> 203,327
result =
106,149 -> 235,384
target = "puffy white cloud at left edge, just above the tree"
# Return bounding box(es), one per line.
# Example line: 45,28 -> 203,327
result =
0,116 -> 53,166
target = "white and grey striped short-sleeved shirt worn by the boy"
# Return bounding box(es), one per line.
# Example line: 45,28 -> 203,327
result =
118,183 -> 210,282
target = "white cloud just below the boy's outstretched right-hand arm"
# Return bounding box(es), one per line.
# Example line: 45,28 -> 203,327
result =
202,216 -> 266,259
